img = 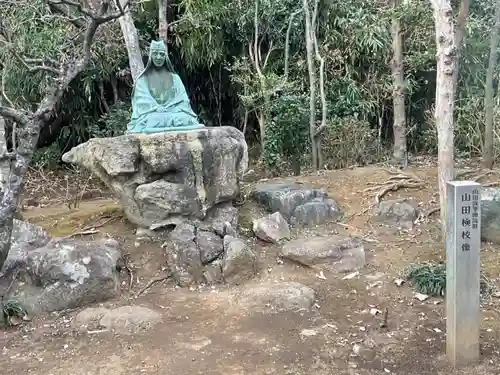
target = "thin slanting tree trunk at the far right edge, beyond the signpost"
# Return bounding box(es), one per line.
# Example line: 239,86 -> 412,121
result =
483,0 -> 500,169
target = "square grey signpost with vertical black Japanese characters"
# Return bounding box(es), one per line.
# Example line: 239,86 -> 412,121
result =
446,181 -> 481,366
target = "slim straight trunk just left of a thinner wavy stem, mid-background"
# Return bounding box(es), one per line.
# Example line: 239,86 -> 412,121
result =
302,0 -> 318,171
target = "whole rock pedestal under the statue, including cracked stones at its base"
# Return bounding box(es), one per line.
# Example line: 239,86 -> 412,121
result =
63,127 -> 257,286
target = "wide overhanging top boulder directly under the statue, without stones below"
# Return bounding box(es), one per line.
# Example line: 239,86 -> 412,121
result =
63,127 -> 248,229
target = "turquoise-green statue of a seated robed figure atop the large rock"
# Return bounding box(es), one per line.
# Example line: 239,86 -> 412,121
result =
127,41 -> 204,133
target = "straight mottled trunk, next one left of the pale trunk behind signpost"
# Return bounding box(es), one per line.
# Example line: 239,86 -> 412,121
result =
391,0 -> 408,167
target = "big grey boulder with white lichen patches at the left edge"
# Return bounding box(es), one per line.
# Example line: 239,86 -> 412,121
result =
0,231 -> 121,314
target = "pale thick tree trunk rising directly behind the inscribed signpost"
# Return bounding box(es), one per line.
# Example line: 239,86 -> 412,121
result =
432,0 -> 456,229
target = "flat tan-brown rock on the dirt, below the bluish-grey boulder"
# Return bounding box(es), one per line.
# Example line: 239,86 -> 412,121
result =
281,235 -> 366,272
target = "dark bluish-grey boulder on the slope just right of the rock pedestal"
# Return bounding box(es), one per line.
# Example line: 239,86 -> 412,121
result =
252,182 -> 342,226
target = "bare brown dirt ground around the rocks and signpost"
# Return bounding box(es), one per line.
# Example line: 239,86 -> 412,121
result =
0,166 -> 500,375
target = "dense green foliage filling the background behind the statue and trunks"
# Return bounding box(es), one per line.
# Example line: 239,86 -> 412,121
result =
0,0 -> 500,170
